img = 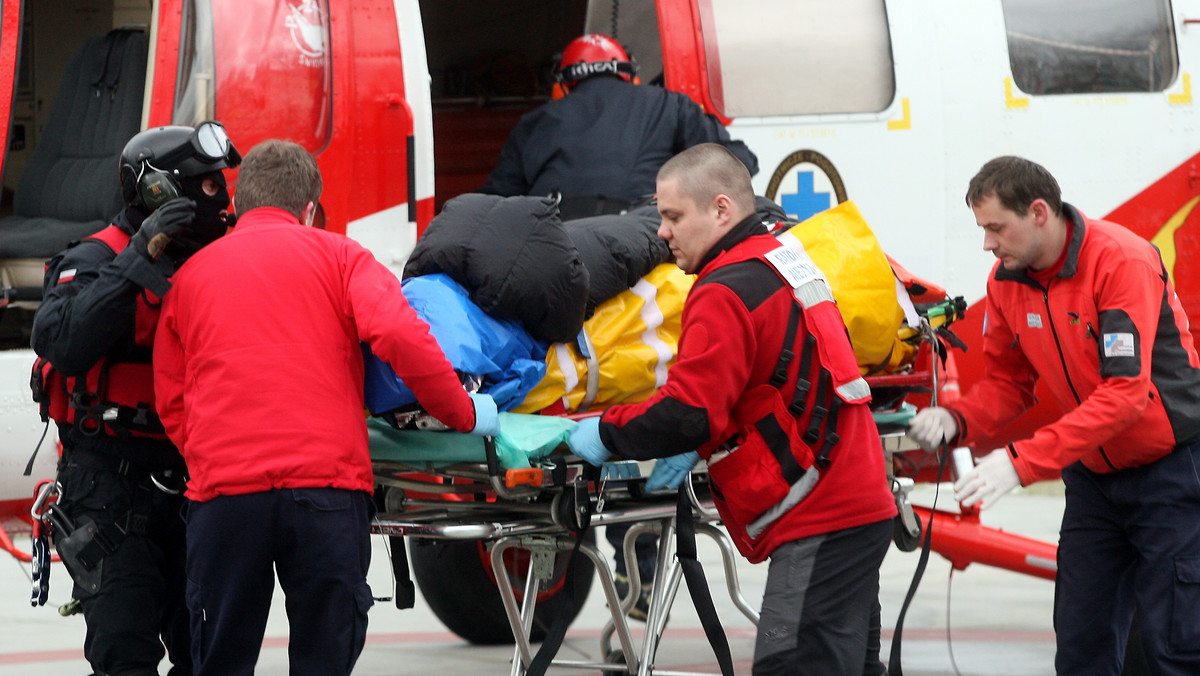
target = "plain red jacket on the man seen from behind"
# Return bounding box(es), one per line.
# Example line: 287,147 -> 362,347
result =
154,208 -> 475,501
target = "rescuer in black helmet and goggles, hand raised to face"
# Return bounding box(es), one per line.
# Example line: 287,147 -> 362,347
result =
31,121 -> 241,676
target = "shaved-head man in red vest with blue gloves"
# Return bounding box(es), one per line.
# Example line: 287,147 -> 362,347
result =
569,144 -> 896,676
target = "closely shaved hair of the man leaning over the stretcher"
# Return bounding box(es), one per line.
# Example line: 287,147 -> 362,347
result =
658,143 -> 755,216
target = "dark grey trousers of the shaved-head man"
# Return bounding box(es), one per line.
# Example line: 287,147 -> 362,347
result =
754,519 -> 892,676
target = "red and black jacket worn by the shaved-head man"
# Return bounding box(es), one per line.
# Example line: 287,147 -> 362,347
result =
600,217 -> 895,562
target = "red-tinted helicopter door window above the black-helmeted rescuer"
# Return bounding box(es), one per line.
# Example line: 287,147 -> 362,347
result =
173,0 -> 332,154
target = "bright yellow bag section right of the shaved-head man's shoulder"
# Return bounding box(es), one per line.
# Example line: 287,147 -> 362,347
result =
779,201 -> 916,376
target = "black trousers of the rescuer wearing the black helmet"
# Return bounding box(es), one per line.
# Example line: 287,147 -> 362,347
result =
58,458 -> 192,676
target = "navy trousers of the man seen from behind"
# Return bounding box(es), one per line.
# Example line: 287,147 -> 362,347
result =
187,489 -> 373,676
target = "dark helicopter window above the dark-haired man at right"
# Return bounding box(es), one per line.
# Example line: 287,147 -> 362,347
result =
1002,0 -> 1178,94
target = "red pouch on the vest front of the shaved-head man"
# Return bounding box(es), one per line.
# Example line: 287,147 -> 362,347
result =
708,384 -> 814,528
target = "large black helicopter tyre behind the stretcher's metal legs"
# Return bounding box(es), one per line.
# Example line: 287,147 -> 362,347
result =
408,531 -> 595,645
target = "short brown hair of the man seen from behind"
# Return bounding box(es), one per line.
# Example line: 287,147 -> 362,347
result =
234,139 -> 322,219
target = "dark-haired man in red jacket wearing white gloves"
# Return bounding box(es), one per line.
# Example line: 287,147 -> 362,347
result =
908,157 -> 1200,676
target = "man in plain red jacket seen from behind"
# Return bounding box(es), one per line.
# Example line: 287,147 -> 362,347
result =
154,140 -> 499,676
